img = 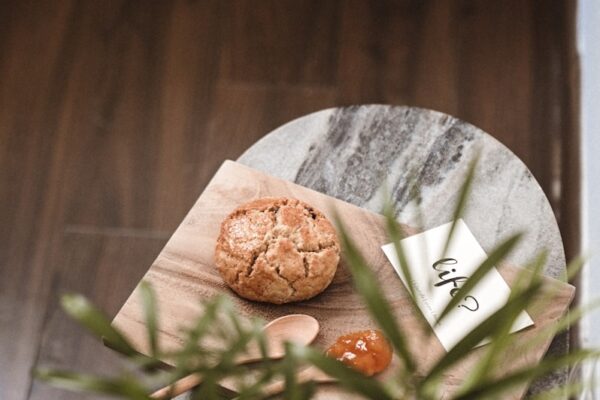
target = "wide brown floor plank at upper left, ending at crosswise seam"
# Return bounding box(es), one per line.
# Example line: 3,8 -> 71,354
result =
53,2 -> 180,228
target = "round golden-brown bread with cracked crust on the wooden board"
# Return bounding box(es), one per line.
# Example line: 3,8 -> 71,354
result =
215,198 -> 340,304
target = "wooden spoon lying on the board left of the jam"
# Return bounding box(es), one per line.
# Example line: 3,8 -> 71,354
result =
150,314 -> 319,399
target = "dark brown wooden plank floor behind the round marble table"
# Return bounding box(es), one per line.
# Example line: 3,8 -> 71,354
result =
0,0 -> 579,400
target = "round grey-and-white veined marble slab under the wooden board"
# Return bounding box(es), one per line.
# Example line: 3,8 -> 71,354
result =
238,105 -> 568,392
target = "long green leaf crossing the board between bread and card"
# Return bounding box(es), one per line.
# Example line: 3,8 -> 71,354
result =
336,215 -> 416,372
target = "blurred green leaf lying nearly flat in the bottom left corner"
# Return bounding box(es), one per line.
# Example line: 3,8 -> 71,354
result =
34,369 -> 149,400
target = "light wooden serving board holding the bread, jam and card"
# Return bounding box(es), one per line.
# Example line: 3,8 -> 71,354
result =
113,161 -> 574,399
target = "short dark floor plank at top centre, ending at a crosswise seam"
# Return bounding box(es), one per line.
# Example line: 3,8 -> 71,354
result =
219,0 -> 339,85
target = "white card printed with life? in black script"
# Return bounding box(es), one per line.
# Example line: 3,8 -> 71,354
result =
381,219 -> 533,351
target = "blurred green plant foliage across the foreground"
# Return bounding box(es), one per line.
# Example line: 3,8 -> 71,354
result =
34,162 -> 600,400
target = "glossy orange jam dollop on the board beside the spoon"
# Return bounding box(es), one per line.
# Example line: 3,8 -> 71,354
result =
327,329 -> 392,376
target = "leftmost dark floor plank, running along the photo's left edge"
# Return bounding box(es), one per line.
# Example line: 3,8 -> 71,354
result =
0,2 -> 79,399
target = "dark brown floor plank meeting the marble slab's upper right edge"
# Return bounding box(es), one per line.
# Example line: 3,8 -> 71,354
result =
455,1 -> 540,166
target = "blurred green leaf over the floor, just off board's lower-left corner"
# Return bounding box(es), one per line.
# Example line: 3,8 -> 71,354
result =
61,294 -> 139,356
